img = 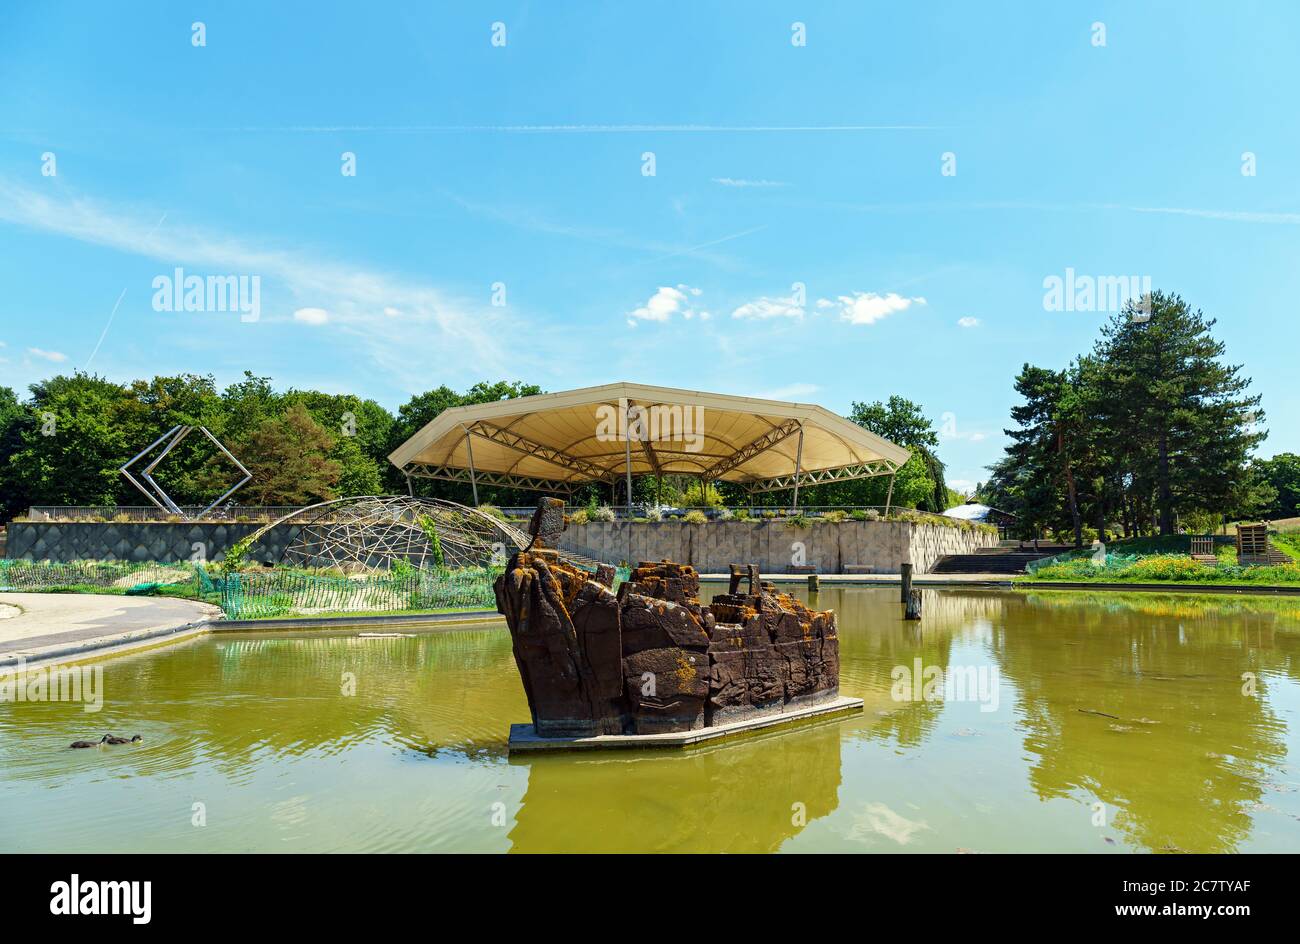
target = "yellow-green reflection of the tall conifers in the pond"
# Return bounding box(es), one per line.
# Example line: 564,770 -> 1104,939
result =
992,593 -> 1300,852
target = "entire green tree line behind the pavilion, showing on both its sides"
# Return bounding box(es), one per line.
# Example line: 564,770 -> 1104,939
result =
0,372 -> 958,519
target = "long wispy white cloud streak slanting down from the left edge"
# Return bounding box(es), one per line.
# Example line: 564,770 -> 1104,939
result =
0,178 -> 517,390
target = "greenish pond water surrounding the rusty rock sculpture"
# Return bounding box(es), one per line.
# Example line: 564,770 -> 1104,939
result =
0,585 -> 1300,853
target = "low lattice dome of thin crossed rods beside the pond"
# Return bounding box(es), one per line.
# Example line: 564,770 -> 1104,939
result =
250,495 -> 528,572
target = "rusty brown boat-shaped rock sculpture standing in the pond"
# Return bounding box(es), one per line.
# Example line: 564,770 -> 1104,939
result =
495,506 -> 840,737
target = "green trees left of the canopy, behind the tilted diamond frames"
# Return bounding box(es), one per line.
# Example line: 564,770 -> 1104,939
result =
0,372 -> 542,519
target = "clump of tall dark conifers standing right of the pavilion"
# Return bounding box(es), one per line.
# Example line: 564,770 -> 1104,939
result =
979,293 -> 1274,544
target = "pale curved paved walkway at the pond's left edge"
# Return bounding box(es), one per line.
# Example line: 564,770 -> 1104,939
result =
0,593 -> 221,670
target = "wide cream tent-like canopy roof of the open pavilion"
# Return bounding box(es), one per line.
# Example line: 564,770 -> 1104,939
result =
389,384 -> 910,494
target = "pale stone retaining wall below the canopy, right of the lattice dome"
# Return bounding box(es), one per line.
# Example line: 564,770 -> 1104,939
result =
560,520 -> 997,573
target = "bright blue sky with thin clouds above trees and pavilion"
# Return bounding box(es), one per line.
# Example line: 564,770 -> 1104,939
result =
0,0 -> 1300,496
